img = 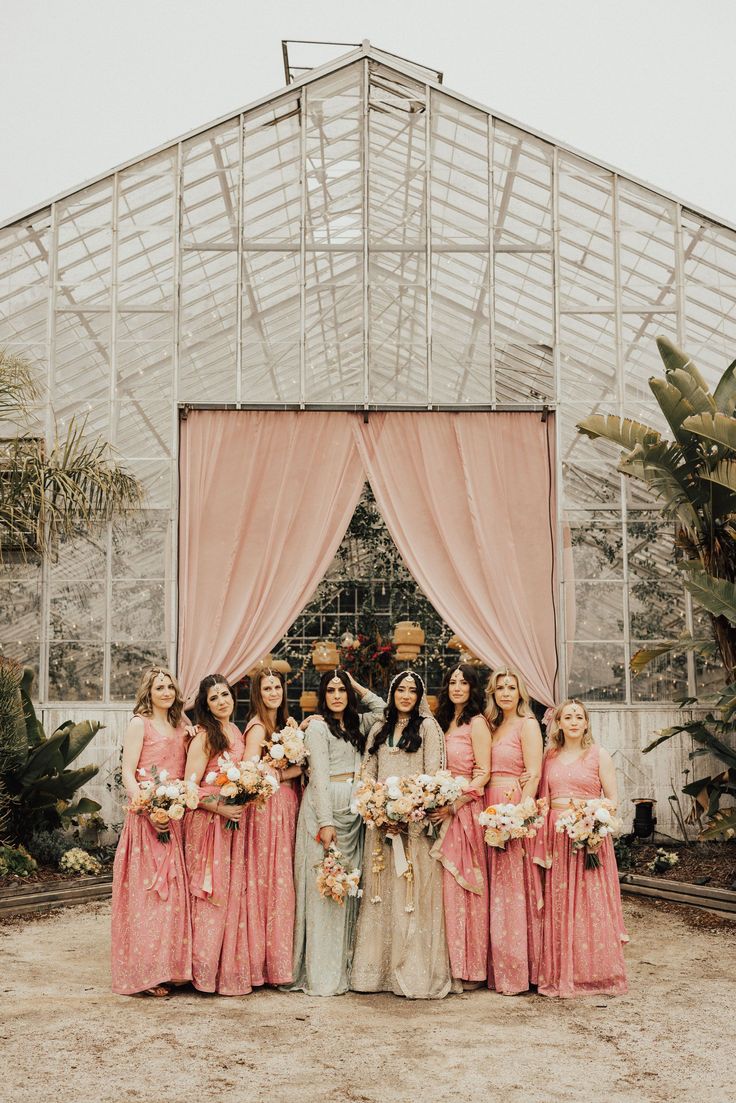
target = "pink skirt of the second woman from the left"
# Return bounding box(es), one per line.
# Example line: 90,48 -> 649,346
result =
184,808 -> 252,996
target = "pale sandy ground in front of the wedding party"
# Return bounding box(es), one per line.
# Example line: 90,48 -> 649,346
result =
0,898 -> 736,1103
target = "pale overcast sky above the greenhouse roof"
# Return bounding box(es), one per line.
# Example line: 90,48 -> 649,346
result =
0,0 -> 736,224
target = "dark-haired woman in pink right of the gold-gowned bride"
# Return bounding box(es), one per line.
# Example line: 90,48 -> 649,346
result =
429,663 -> 491,990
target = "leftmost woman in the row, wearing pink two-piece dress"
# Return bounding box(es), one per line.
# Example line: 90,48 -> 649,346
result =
113,666 -> 192,996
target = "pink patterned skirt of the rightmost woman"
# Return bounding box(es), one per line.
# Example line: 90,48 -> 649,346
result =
538,808 -> 629,997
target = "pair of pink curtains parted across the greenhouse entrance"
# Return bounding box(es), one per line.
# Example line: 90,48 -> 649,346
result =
179,410 -> 556,704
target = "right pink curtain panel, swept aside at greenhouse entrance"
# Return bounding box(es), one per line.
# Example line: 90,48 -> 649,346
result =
353,413 -> 557,705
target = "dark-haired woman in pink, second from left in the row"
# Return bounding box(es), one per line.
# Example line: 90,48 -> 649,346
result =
184,674 -> 250,996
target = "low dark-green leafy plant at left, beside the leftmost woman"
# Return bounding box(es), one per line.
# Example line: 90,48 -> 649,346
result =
0,662 -> 103,842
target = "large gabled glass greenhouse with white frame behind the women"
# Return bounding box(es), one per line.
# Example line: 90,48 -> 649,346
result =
0,42 -> 736,825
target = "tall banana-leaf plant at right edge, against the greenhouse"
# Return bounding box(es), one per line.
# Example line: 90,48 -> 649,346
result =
577,338 -> 736,838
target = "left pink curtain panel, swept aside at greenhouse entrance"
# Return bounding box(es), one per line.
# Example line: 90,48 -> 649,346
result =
179,410 -> 365,697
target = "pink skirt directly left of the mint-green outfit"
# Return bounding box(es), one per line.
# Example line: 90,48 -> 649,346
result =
244,784 -> 299,985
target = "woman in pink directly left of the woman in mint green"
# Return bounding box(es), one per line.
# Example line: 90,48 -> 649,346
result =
245,670 -> 301,985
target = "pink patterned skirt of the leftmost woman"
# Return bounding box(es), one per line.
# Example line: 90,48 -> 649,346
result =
111,813 -> 192,996
